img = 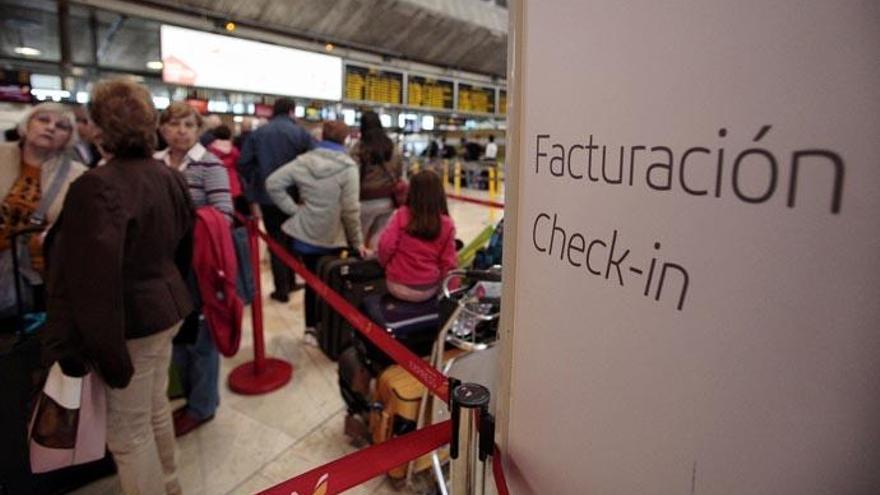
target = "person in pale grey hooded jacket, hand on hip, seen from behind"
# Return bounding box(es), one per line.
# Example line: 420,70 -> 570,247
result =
266,121 -> 369,334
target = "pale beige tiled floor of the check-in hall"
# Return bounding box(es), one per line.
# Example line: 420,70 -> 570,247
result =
74,187 -> 501,495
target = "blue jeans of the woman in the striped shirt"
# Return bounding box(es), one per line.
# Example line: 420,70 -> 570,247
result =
173,315 -> 220,419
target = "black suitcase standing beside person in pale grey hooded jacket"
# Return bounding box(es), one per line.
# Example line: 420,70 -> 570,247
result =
315,256 -> 386,361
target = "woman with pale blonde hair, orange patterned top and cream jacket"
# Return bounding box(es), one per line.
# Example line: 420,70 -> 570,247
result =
0,103 -> 86,316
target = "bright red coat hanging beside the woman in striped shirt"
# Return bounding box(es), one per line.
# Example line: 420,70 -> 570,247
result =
193,206 -> 243,357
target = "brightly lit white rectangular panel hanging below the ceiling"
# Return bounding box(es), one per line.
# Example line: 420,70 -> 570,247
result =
161,25 -> 342,100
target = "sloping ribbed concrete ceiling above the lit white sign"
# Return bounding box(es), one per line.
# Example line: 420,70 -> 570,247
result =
144,0 -> 507,77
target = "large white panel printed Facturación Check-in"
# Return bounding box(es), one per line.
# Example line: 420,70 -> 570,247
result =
507,0 -> 880,495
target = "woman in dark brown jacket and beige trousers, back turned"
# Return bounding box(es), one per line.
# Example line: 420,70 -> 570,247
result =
45,79 -> 193,494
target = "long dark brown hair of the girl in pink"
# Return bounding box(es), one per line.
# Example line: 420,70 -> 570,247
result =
405,170 -> 449,241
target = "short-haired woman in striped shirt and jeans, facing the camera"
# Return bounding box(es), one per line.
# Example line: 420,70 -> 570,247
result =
154,102 -> 233,436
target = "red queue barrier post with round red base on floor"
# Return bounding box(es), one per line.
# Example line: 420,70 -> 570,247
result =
229,217 -> 293,395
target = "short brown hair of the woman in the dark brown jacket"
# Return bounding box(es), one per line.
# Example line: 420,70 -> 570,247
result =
89,79 -> 157,158
